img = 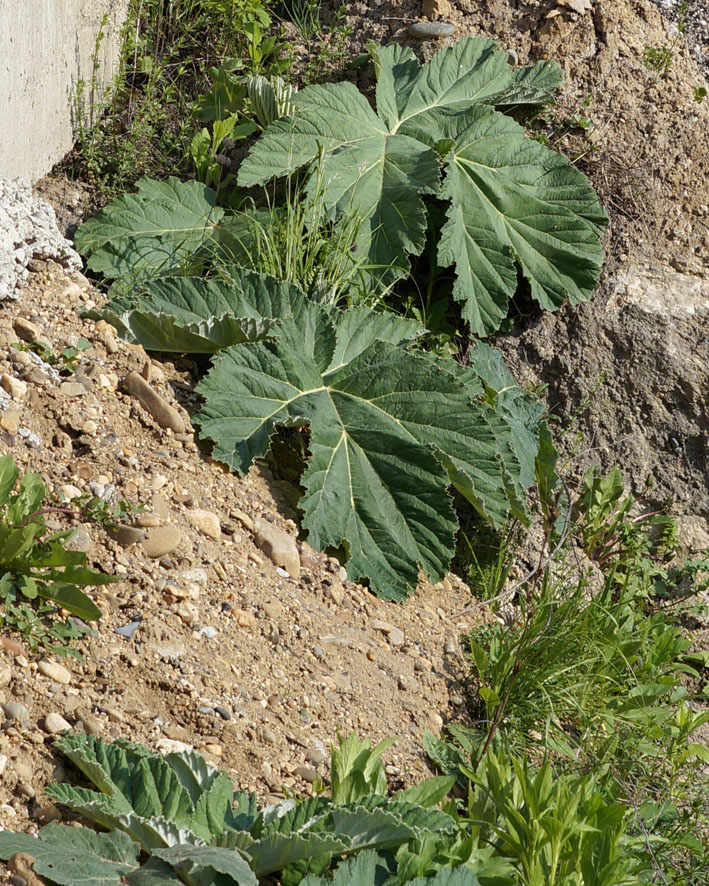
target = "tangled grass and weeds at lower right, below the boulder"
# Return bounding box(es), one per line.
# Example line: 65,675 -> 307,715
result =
450,462 -> 709,886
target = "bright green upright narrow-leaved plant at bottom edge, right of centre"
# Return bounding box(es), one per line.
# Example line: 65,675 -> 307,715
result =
424,744 -> 649,886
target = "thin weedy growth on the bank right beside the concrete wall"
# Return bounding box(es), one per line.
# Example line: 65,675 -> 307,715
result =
68,0 -> 290,197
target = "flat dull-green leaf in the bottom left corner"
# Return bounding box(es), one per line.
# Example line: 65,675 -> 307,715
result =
0,824 -> 140,886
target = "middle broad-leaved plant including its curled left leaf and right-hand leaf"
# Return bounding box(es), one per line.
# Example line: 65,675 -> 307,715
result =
88,268 -> 542,599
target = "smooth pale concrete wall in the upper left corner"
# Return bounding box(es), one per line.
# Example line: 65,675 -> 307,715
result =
0,0 -> 128,182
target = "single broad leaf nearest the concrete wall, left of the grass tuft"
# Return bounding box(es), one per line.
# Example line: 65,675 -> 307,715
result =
74,177 -> 224,281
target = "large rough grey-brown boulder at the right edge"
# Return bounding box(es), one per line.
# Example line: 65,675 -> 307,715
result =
496,264 -> 709,515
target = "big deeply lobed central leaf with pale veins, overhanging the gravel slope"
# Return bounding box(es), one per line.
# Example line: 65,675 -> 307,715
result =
195,305 -> 532,599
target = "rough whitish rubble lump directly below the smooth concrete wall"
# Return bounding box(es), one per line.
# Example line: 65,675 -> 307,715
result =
0,178 -> 82,302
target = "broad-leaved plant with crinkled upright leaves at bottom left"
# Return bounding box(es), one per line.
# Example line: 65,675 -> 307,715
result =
0,733 -> 455,886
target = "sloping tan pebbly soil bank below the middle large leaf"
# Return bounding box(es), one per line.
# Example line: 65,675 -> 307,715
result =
0,263 -> 492,829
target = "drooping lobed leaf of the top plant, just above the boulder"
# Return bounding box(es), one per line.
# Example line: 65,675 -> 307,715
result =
438,107 -> 605,335
